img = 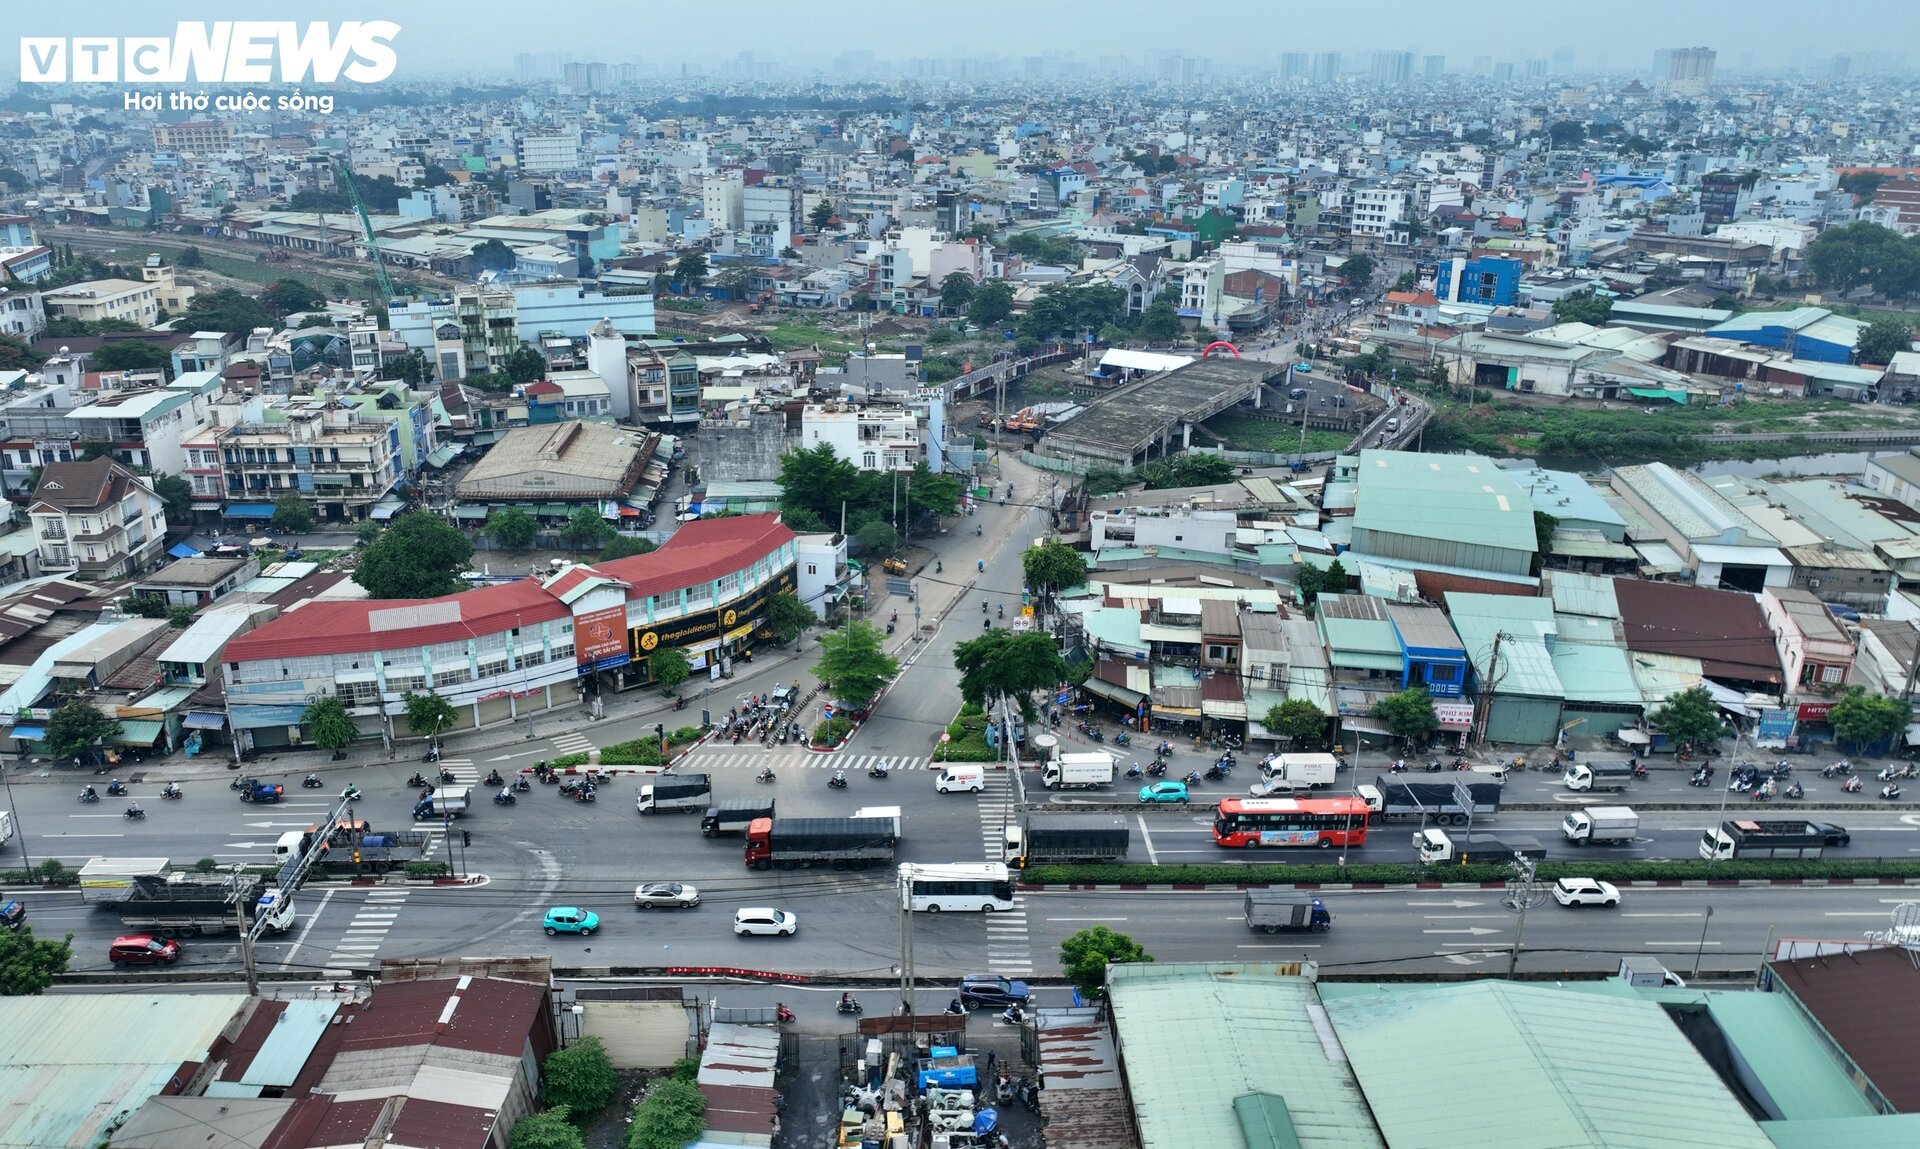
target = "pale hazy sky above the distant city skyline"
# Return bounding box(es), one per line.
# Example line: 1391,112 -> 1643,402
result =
15,0 -> 1920,79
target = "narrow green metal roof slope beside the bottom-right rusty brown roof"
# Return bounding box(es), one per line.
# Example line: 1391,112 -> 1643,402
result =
1707,993 -> 1873,1122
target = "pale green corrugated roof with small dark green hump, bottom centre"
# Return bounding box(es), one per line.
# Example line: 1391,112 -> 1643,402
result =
1108,963 -> 1390,1149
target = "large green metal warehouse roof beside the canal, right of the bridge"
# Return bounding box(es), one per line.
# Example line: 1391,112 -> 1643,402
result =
1354,452 -> 1538,553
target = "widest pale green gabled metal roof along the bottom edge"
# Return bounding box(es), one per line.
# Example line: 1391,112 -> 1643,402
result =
1320,982 -> 1772,1149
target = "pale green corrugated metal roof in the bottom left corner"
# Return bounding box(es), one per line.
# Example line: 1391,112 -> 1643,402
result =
0,993 -> 246,1149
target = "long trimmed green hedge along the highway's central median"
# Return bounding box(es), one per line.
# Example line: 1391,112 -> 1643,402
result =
1023,855 -> 1920,886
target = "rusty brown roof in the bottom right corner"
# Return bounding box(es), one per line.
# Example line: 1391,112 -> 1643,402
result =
1772,949 -> 1920,1112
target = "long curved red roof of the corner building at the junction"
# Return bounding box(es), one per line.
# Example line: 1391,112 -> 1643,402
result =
225,515 -> 793,663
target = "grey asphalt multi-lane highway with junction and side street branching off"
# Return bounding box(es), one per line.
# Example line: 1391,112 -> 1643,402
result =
8,463 -> 1920,978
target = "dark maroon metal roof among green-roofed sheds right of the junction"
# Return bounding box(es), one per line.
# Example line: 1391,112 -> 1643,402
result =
1613,578 -> 1780,682
